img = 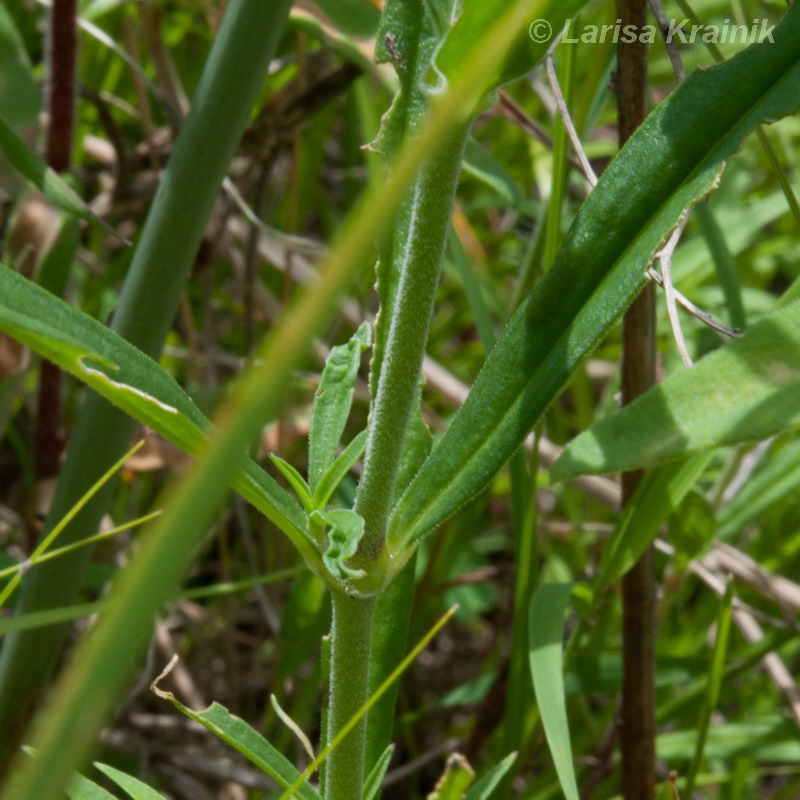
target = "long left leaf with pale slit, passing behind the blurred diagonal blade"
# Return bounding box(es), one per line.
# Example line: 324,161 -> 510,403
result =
0,265 -> 314,556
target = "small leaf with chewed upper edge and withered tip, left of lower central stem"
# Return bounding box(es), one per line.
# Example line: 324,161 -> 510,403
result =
152,674 -> 320,800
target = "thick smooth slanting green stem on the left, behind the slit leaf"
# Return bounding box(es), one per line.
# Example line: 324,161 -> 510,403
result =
0,0 -> 290,772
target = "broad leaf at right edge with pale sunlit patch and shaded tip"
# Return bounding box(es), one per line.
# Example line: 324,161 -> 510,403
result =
551,301 -> 800,480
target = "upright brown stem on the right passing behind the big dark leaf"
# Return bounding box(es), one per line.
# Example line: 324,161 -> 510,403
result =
616,0 -> 656,800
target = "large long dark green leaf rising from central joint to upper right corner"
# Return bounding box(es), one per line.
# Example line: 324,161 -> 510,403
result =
389,1 -> 800,552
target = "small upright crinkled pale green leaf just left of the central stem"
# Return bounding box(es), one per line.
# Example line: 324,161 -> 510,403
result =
308,322 -> 371,494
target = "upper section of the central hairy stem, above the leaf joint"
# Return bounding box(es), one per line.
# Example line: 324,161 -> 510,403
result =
355,124 -> 469,560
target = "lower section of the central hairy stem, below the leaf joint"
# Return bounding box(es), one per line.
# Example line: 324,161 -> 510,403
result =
325,592 -> 375,800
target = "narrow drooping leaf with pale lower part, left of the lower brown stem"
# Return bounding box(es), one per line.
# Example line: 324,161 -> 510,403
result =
528,583 -> 579,800
